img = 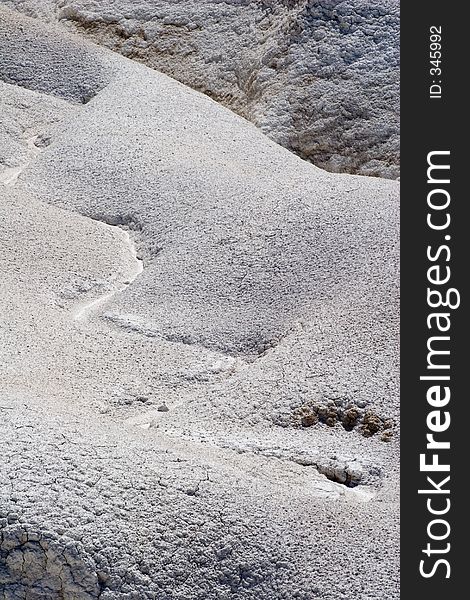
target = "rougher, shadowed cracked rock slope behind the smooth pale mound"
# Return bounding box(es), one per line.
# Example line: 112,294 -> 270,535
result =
3,0 -> 399,179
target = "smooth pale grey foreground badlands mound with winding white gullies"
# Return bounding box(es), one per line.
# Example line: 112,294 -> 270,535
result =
0,8 -> 398,600
